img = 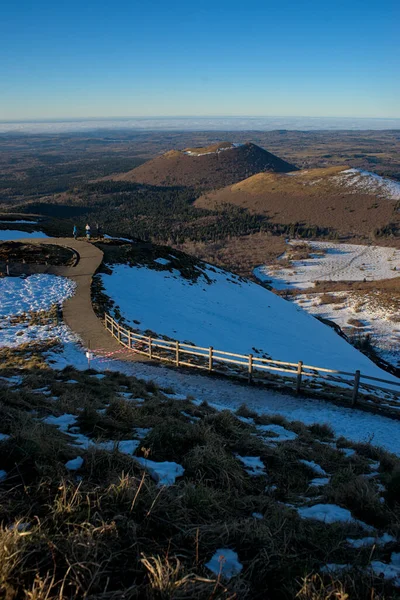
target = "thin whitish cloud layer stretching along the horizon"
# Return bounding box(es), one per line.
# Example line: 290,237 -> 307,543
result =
0,117 -> 400,134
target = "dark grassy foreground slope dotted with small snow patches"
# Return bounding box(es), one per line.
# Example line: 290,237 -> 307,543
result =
0,360 -> 400,600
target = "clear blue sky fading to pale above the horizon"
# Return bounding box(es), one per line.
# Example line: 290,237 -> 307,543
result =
0,0 -> 400,120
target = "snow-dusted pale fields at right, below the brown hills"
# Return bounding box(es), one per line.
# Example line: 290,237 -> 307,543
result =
255,241 -> 400,370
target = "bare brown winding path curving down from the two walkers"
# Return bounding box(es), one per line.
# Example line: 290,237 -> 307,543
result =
18,238 -> 145,360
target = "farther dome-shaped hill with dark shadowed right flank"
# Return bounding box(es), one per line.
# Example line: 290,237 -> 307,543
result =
108,142 -> 296,189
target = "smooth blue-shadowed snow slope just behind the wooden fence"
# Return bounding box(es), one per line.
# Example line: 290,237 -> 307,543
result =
101,263 -> 396,379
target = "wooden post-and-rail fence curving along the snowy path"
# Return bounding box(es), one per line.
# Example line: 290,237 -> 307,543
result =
104,313 -> 400,410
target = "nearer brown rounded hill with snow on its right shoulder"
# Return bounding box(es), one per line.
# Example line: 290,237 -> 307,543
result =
195,166 -> 400,235
